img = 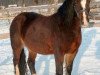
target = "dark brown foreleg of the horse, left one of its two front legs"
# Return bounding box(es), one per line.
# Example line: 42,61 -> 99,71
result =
54,51 -> 64,75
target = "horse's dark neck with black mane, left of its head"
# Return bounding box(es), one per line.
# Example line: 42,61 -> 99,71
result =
57,0 -> 74,24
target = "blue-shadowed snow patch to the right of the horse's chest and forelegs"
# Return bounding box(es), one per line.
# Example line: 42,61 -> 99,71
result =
72,28 -> 100,75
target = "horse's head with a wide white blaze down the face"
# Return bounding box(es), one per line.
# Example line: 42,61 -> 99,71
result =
75,0 -> 89,26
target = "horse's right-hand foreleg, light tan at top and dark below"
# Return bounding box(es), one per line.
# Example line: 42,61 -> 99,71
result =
65,51 -> 77,75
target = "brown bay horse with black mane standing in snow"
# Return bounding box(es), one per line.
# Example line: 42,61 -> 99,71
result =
10,0 -> 88,75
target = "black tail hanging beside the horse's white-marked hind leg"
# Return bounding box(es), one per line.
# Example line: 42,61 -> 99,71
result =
19,49 -> 27,75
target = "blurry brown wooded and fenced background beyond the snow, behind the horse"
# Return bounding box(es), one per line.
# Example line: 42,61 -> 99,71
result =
0,0 -> 100,20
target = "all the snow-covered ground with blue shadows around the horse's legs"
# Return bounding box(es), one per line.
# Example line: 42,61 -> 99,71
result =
0,27 -> 100,75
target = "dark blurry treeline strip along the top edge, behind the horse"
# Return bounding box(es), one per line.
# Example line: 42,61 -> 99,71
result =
0,0 -> 64,7
